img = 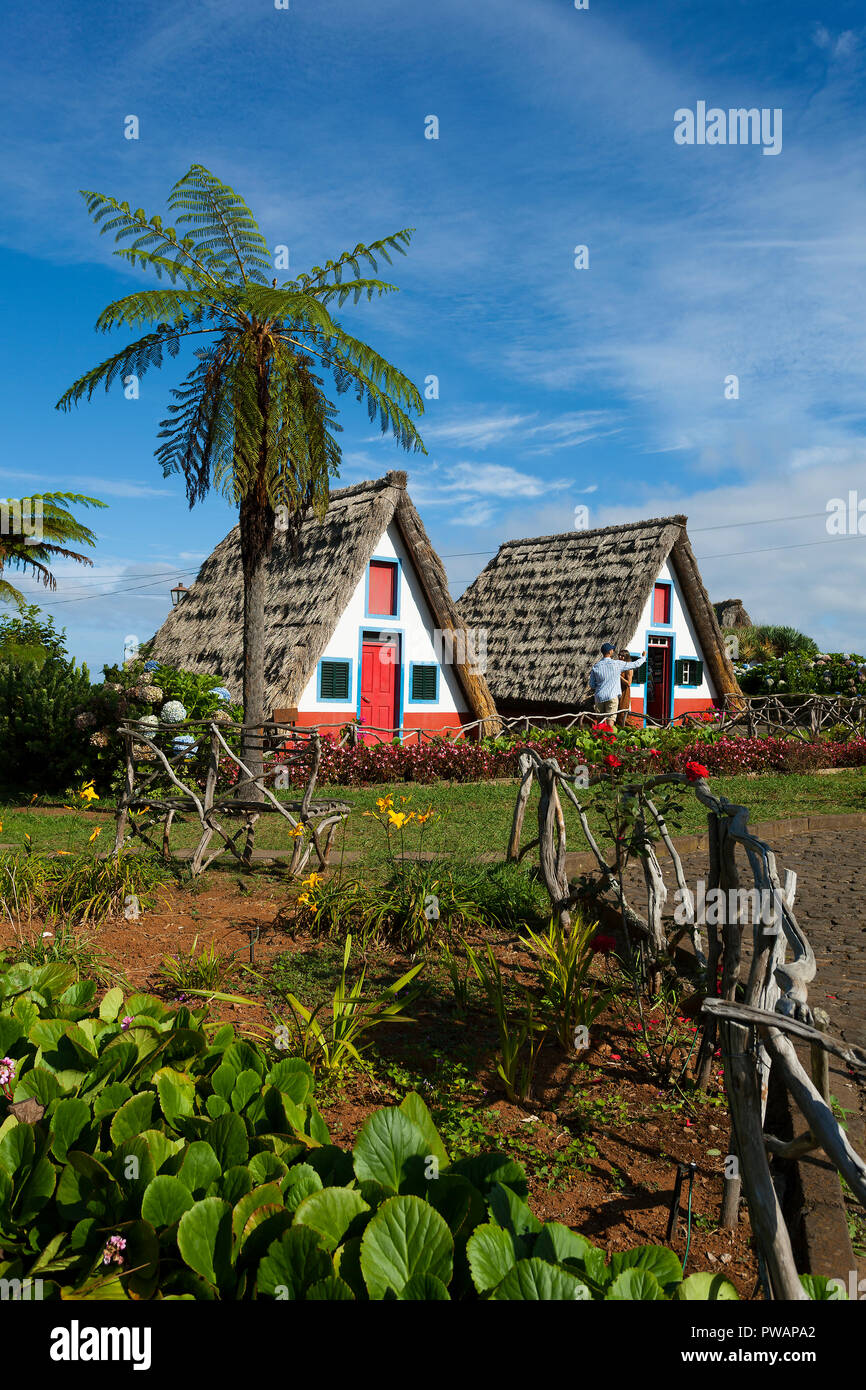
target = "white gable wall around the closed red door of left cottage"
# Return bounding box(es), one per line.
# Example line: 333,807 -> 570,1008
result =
297,521 -> 467,723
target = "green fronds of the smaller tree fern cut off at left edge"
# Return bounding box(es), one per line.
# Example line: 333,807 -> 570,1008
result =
0,492 -> 106,609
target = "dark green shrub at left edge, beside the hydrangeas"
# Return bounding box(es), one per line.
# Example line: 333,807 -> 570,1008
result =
0,605 -> 90,792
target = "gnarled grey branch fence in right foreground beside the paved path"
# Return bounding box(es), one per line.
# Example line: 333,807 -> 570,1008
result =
507,749 -> 866,1300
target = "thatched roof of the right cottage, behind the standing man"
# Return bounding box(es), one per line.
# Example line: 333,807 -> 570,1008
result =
457,516 -> 738,709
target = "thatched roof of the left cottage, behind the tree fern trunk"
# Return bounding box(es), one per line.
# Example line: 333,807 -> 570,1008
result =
152,471 -> 495,719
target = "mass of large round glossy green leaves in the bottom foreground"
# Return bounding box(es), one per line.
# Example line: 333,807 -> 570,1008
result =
0,963 -> 827,1302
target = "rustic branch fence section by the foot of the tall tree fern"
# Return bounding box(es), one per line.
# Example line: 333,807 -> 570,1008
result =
114,720 -> 352,876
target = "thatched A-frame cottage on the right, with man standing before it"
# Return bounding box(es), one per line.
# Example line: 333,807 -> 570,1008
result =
457,516 -> 738,719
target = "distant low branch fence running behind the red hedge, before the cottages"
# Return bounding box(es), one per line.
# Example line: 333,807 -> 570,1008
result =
291,695 -> 866,746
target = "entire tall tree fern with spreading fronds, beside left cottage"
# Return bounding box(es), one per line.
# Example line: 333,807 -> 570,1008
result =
57,164 -> 425,771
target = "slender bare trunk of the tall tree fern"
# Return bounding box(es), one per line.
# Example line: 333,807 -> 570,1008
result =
240,495 -> 274,801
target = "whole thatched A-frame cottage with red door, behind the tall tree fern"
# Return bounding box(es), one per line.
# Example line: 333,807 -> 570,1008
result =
152,471 -> 495,733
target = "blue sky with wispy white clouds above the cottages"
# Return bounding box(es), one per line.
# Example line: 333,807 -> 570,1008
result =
0,0 -> 866,674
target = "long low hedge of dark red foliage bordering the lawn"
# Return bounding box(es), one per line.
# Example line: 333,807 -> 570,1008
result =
272,737 -> 866,787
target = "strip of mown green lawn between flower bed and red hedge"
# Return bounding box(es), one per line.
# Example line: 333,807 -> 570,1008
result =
0,769 -> 866,865
